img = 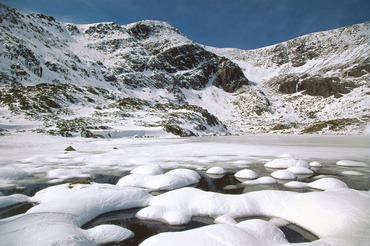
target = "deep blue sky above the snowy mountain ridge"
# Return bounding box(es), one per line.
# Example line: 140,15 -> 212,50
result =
0,0 -> 370,49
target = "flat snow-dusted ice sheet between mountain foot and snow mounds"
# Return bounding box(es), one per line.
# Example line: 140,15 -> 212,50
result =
0,133 -> 370,187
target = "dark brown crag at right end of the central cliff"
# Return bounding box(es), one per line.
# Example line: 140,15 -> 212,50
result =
212,57 -> 248,92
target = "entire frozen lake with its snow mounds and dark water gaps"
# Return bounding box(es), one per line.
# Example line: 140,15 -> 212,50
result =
0,132 -> 370,245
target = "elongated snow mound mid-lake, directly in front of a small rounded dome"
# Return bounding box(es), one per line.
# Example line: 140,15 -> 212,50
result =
117,169 -> 200,190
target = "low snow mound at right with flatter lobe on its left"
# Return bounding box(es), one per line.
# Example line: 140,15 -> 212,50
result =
284,178 -> 348,190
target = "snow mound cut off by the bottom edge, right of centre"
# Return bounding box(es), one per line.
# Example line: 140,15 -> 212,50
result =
141,220 -> 288,246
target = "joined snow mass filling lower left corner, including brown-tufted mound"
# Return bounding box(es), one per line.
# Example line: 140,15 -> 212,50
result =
0,183 -> 151,246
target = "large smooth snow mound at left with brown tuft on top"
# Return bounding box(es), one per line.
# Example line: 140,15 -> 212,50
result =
27,183 -> 151,225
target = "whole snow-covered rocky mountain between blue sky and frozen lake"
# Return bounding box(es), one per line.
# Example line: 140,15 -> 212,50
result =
0,5 -> 370,137
